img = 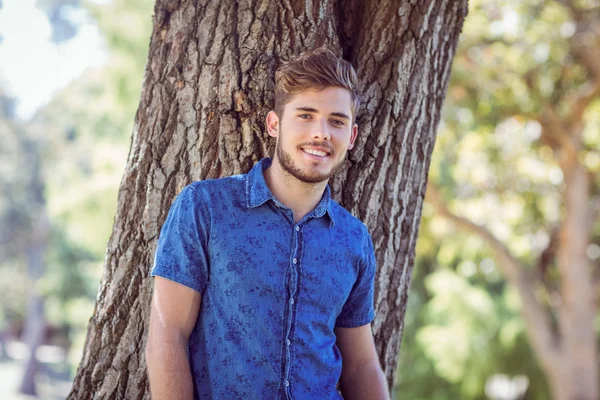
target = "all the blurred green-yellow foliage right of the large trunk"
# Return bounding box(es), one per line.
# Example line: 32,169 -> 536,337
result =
397,0 -> 600,399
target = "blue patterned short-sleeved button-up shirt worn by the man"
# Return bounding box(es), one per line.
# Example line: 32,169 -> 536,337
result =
152,158 -> 375,400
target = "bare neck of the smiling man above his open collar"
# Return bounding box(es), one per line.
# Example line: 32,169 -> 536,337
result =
264,158 -> 327,222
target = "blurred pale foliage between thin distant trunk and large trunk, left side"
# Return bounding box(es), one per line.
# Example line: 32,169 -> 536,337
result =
33,1 -> 153,332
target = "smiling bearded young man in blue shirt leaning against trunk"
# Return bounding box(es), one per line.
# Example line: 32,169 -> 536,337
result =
146,49 -> 389,400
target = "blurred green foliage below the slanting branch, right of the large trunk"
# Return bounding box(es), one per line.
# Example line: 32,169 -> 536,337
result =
395,219 -> 549,400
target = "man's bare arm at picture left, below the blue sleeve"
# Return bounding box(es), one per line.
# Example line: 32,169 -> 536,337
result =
146,276 -> 202,400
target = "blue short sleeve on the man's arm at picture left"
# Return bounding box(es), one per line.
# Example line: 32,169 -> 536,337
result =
151,186 -> 208,293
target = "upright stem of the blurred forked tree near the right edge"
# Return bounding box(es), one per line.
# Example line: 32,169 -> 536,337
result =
552,161 -> 600,400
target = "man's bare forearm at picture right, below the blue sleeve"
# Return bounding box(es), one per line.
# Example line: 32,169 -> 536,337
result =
335,325 -> 390,400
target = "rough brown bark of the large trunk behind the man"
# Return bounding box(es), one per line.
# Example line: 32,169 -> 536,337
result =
69,0 -> 467,399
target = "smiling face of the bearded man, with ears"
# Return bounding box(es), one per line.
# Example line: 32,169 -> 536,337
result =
267,87 -> 358,183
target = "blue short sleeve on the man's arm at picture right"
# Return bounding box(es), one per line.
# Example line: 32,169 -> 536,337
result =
335,234 -> 377,328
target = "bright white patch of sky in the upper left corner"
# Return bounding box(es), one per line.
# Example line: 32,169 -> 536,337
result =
0,0 -> 107,120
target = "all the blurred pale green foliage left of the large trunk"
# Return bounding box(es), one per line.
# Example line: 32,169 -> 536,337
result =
0,0 -> 154,346
